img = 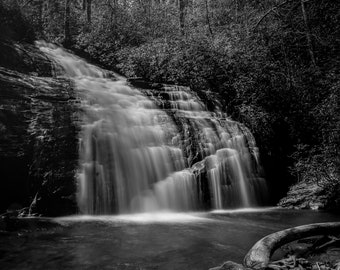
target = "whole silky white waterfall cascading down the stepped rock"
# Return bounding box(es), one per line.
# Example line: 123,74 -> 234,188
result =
37,42 -> 266,214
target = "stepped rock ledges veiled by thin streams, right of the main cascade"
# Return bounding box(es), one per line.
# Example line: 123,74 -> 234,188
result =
129,79 -> 268,209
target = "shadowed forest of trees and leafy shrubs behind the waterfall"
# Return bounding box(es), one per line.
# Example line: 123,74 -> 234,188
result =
0,0 -> 340,208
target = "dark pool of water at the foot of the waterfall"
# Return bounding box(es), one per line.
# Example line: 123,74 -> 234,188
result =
0,209 -> 340,270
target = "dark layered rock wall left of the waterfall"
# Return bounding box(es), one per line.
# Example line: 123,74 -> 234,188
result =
0,43 -> 78,216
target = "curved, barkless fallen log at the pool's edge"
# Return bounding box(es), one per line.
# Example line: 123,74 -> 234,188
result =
243,222 -> 340,269
